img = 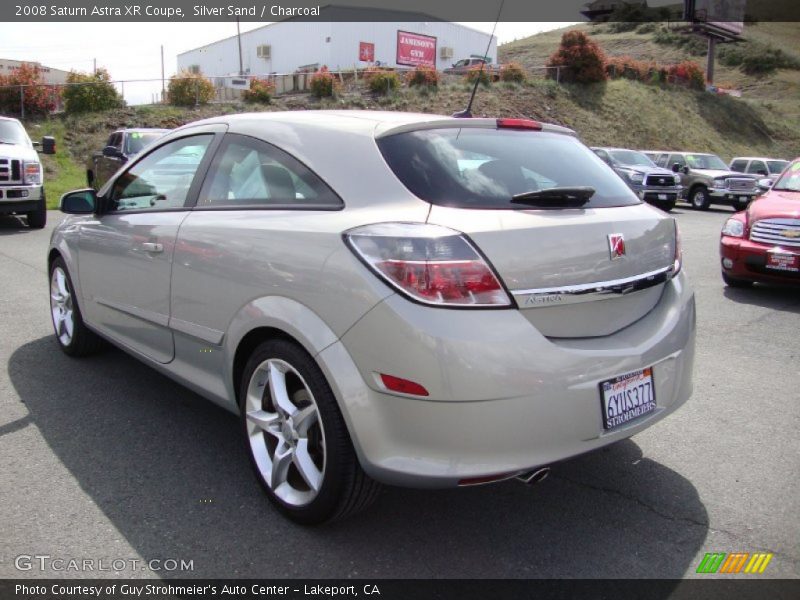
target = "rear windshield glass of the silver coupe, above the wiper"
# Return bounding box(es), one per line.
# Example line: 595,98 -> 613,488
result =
378,128 -> 640,210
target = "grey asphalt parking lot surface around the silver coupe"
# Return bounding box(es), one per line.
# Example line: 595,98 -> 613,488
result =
0,206 -> 800,578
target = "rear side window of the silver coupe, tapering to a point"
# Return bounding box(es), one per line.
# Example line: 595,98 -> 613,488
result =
197,134 -> 343,208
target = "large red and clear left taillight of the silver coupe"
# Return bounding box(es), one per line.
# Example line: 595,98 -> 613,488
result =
344,223 -> 511,308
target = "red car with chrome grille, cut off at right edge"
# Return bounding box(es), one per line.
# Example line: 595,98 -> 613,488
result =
719,158 -> 800,287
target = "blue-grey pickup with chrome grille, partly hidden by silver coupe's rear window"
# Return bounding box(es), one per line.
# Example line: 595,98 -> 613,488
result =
592,147 -> 683,212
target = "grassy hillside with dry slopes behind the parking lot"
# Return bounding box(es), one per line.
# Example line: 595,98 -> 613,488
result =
27,23 -> 800,207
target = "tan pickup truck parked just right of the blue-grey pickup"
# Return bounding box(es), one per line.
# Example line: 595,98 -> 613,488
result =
656,152 -> 761,210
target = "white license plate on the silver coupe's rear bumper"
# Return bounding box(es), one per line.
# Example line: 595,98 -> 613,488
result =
600,367 -> 656,429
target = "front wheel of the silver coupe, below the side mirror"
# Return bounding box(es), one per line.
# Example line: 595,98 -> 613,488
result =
50,257 -> 104,357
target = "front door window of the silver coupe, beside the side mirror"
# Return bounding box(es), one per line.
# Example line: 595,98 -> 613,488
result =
111,134 -> 214,212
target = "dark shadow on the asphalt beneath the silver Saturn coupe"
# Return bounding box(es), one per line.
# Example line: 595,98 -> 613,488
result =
8,337 -> 708,578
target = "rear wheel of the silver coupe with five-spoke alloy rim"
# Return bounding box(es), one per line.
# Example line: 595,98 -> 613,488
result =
239,339 -> 381,525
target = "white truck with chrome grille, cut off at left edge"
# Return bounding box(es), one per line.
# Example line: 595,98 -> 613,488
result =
0,117 -> 47,229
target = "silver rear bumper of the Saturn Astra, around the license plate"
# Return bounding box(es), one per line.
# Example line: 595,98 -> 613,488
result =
318,274 -> 695,487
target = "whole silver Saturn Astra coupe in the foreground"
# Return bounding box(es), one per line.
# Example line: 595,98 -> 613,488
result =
48,111 -> 695,523
